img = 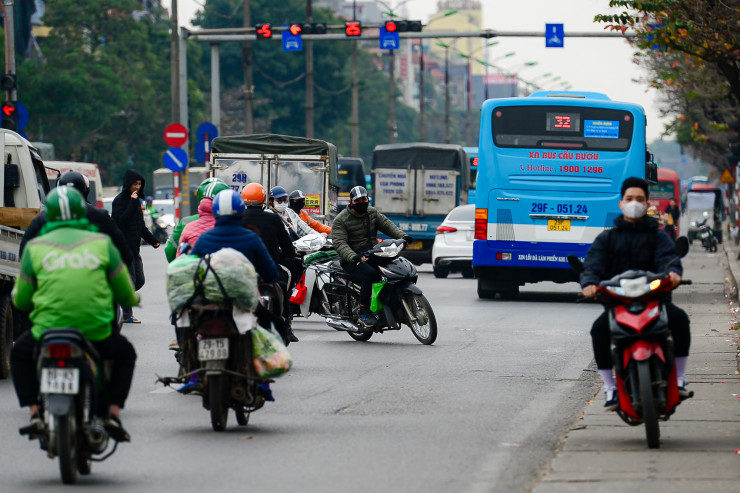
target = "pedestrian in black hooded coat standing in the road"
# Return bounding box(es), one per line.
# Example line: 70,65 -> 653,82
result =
113,169 -> 159,324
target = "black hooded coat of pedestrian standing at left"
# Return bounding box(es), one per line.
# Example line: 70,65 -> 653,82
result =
113,169 -> 159,257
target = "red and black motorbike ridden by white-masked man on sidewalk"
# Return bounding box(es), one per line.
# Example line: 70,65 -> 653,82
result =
568,237 -> 693,448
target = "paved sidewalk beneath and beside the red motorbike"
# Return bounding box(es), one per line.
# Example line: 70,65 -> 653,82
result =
533,242 -> 740,493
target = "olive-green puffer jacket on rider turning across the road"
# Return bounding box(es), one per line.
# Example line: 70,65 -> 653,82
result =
331,207 -> 406,262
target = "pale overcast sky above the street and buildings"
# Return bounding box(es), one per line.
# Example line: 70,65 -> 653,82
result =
168,0 -> 668,142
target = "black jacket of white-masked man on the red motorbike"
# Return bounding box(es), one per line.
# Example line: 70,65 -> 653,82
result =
581,216 -> 683,288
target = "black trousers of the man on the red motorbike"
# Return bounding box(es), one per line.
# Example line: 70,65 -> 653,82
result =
591,303 -> 691,370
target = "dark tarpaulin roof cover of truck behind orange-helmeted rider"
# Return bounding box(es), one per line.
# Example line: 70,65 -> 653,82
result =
211,134 -> 339,183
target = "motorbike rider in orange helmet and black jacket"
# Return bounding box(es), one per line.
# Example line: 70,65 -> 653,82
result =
242,182 -> 303,342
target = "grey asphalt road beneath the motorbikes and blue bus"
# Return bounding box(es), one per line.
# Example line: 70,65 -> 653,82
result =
0,247 -> 601,492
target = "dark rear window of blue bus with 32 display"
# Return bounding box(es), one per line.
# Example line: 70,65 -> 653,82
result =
491,106 -> 635,151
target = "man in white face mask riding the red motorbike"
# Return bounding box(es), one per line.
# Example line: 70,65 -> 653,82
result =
580,177 -> 691,411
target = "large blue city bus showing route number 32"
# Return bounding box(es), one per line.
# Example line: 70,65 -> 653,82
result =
473,91 -> 657,299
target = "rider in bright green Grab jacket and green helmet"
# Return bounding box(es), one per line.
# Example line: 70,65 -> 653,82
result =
11,186 -> 139,442
